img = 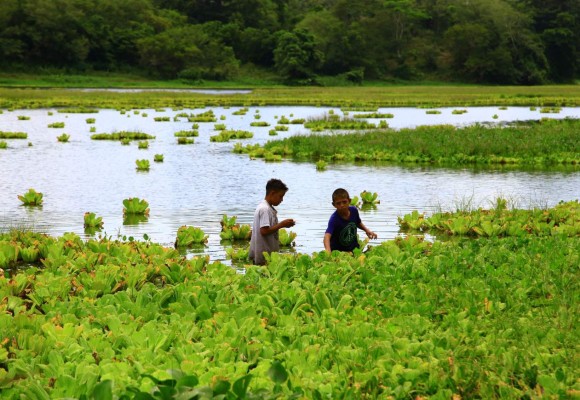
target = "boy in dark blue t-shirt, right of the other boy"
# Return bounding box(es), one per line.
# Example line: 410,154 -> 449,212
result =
324,188 -> 377,253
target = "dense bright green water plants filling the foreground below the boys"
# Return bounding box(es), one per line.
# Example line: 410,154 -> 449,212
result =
0,201 -> 580,399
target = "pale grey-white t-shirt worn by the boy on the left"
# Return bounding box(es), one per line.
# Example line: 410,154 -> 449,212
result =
250,200 -> 280,265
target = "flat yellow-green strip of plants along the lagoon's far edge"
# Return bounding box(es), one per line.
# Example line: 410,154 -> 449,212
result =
0,84 -> 580,109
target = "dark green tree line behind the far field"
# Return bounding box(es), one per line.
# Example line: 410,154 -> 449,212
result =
0,0 -> 580,85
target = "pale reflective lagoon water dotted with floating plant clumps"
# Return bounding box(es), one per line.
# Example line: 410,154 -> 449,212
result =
0,106 -> 580,260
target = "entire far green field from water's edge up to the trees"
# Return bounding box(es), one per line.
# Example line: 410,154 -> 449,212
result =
0,74 -> 580,109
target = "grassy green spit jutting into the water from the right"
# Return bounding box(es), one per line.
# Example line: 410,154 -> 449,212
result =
234,119 -> 580,166
